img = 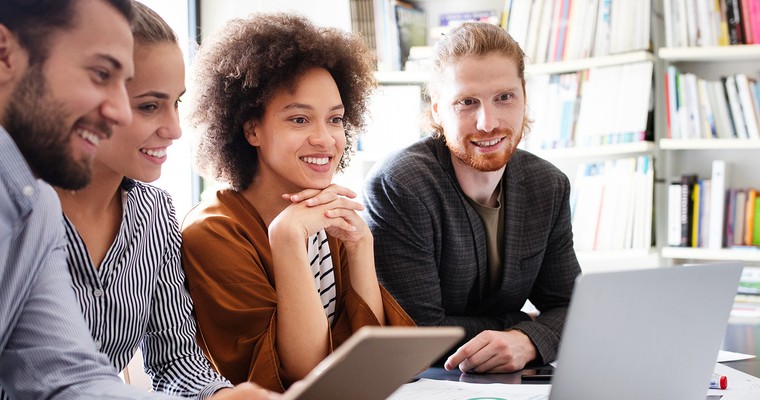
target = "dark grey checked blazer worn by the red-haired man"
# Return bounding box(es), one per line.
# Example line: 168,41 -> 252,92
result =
364,138 -> 580,363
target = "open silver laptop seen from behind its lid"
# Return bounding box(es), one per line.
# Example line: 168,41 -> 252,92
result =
549,262 -> 742,400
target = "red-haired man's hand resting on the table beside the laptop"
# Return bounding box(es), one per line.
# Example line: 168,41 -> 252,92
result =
444,330 -> 537,373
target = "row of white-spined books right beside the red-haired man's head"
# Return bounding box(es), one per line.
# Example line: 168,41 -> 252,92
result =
525,61 -> 653,150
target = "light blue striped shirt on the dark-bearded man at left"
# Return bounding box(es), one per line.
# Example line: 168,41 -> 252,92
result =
0,127 -> 174,399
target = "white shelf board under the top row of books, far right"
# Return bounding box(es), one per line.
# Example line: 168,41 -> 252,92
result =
657,44 -> 760,62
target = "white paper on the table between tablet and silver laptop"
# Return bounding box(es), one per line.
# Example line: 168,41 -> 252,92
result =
388,378 -> 551,400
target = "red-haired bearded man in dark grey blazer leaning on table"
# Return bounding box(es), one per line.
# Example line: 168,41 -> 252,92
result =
364,23 -> 580,372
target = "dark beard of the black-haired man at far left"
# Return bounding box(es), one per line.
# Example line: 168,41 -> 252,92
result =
5,66 -> 92,190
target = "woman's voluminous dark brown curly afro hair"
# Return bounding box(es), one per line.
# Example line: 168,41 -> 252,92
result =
189,13 -> 376,191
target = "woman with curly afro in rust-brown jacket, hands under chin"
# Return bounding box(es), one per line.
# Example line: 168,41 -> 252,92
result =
182,14 -> 414,392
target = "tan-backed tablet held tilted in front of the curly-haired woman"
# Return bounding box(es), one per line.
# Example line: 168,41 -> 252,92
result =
282,326 -> 464,400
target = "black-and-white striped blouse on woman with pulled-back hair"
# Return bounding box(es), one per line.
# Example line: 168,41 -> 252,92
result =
65,178 -> 232,398
